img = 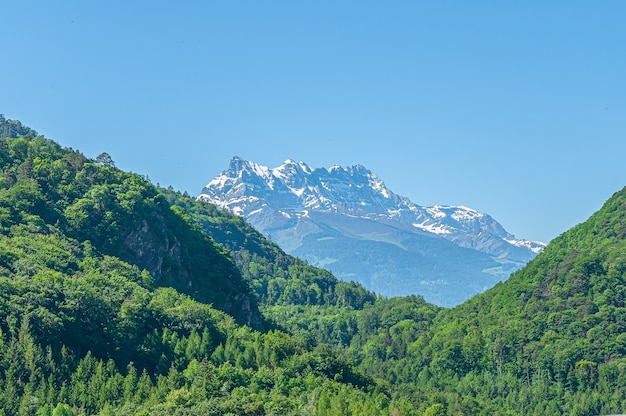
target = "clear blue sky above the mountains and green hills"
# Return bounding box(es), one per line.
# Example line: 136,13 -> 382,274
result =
0,0 -> 626,241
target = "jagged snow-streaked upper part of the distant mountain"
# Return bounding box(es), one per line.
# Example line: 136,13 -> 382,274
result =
199,157 -> 545,261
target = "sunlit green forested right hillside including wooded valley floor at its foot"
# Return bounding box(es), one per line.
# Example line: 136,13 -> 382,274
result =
188,181 -> 626,415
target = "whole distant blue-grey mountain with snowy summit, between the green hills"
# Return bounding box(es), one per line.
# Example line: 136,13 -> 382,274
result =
198,157 -> 544,306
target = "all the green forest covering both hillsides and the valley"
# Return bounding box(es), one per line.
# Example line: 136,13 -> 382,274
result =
0,115 -> 626,416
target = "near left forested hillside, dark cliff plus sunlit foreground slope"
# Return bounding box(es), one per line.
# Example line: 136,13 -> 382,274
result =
0,124 -> 391,415
